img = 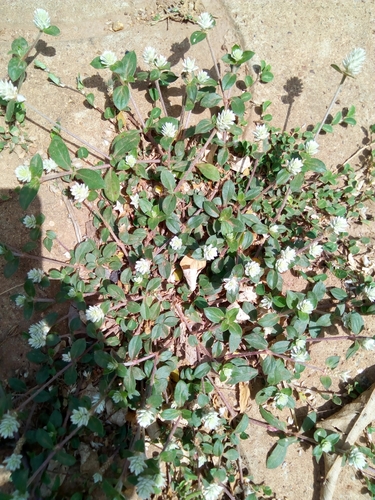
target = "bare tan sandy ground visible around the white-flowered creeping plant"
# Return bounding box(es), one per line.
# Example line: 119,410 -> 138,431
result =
0,0 -> 375,500
